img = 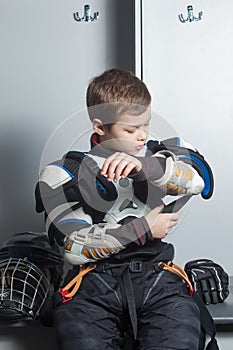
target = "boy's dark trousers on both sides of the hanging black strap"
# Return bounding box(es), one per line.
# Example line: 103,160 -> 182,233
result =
54,270 -> 201,350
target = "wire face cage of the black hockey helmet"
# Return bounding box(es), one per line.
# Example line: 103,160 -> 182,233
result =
0,258 -> 50,321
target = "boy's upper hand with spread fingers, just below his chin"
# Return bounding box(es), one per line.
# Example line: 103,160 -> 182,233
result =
100,152 -> 142,182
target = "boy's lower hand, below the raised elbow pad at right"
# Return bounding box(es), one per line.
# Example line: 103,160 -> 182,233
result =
145,205 -> 179,239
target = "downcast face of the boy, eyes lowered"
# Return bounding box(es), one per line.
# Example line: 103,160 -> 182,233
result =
97,106 -> 151,155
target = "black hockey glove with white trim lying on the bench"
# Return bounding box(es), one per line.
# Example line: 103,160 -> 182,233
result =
184,259 -> 229,305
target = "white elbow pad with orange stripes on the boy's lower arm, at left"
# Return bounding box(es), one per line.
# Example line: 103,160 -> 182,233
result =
64,223 -> 124,265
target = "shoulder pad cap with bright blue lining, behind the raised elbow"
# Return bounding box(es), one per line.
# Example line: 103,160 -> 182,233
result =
147,137 -> 214,199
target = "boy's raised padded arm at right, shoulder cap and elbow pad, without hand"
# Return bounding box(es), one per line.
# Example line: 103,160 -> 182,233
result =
130,137 -> 214,199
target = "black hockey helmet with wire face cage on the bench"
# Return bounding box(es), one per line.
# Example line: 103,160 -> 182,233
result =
0,232 -> 63,321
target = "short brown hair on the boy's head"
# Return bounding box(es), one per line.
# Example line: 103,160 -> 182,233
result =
86,68 -> 151,124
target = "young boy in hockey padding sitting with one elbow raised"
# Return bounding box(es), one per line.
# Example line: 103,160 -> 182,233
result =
36,69 -> 209,350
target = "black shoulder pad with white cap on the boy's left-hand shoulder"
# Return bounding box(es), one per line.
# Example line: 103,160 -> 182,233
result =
35,151 -> 117,212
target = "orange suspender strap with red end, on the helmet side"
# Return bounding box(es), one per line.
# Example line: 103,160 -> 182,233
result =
58,265 -> 96,303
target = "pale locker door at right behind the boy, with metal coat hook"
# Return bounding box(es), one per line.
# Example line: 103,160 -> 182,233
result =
136,0 -> 233,274
